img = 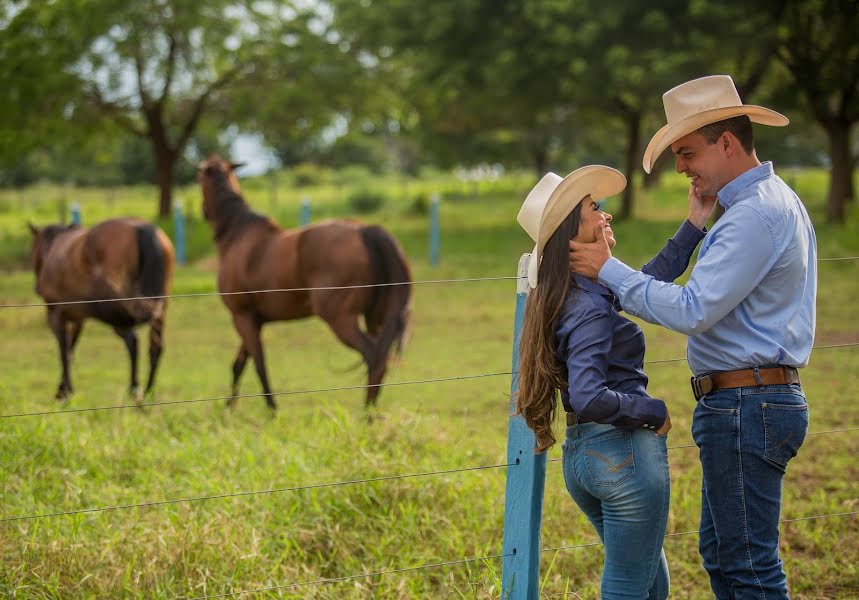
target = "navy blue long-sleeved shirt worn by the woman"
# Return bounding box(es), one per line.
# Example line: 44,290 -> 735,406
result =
555,221 -> 704,429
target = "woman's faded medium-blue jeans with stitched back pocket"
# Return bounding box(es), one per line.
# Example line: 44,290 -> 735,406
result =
563,423 -> 671,600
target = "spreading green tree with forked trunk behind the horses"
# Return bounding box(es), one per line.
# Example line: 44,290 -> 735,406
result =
0,0 -> 340,215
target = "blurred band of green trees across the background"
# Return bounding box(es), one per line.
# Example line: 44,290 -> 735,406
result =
0,0 -> 859,222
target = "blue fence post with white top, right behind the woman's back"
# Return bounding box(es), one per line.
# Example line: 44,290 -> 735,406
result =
501,254 -> 546,600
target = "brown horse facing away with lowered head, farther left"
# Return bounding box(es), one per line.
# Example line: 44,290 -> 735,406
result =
30,219 -> 173,401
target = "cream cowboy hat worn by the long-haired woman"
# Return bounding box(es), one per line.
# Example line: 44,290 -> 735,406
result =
516,165 -> 626,288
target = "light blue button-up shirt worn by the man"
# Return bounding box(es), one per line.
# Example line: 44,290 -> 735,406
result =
599,162 -> 817,375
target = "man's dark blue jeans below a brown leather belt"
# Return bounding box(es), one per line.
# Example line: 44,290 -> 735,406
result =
692,385 -> 808,600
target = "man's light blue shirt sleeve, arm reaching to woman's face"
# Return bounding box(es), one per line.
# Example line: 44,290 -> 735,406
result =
599,206 -> 777,335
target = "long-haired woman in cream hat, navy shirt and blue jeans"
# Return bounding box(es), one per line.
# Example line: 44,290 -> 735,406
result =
517,165 -> 703,600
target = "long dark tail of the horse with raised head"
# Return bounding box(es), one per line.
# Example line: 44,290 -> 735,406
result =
361,225 -> 412,365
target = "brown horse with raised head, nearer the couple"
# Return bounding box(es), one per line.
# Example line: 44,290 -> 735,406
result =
199,157 -> 411,409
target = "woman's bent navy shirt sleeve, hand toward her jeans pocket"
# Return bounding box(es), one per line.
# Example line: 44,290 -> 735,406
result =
560,306 -> 667,429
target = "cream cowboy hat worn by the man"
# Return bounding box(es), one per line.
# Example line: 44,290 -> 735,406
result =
641,75 -> 789,173
